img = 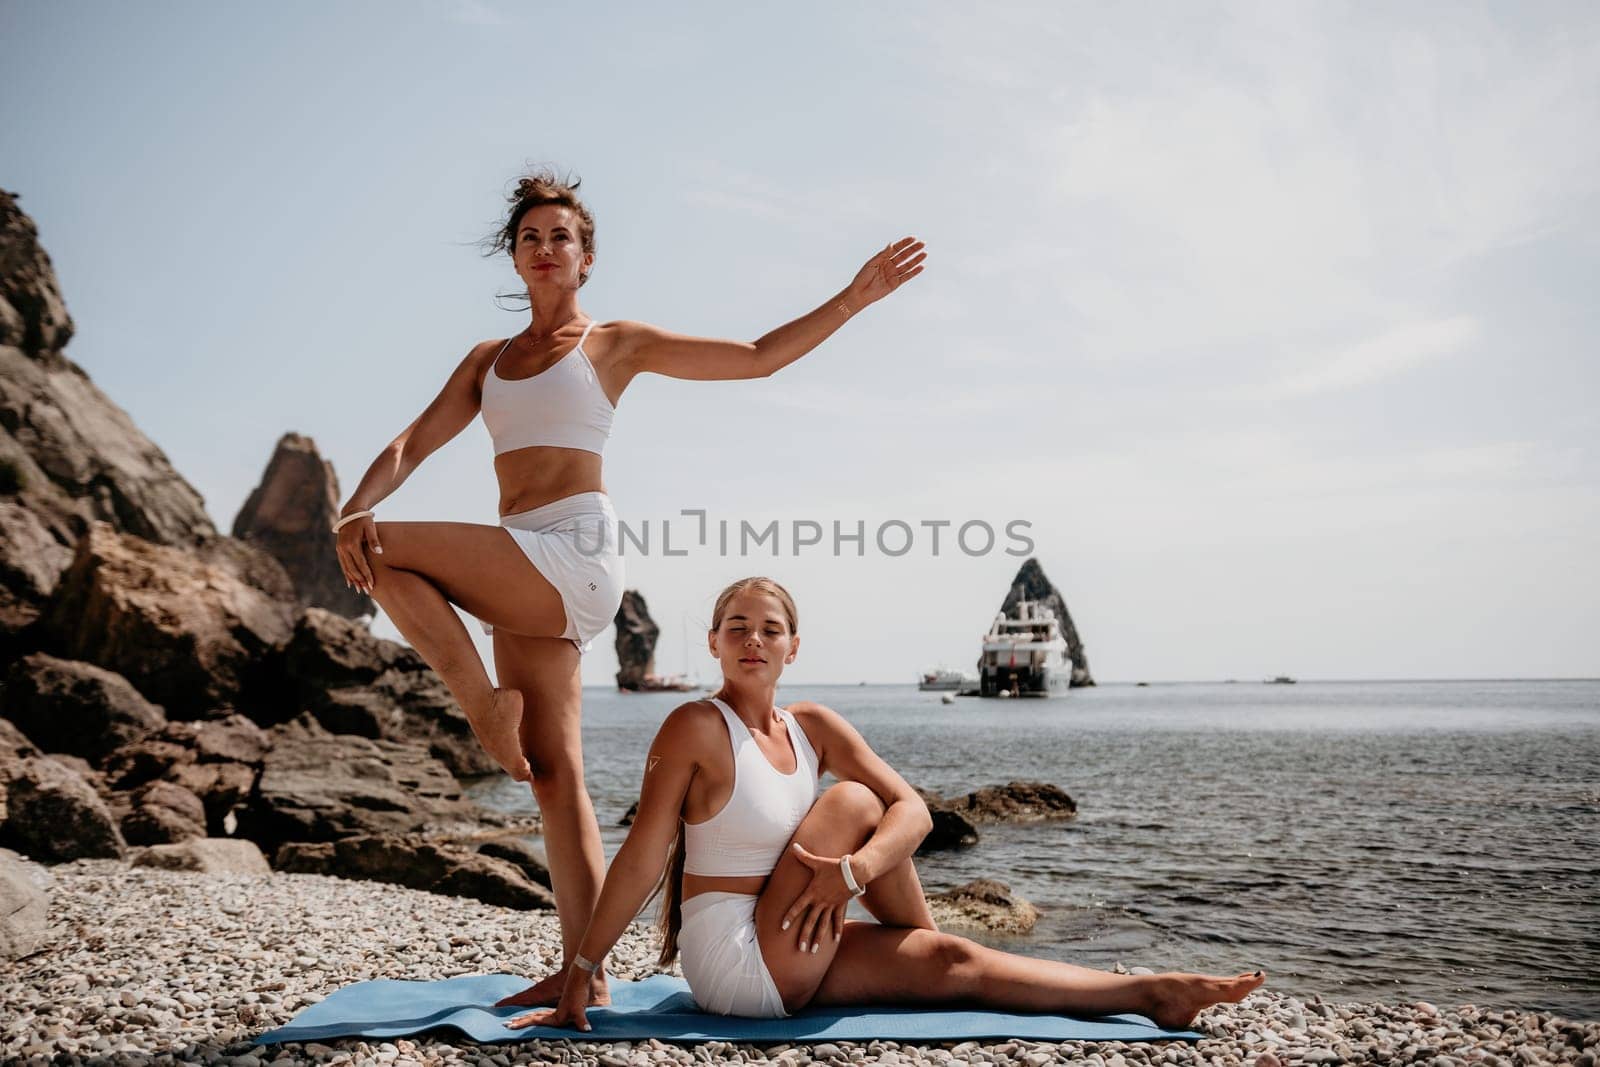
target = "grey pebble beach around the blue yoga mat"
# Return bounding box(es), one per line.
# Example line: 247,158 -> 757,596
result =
0,861 -> 1600,1067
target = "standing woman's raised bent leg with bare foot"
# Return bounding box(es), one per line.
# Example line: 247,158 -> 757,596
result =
366,523 -> 566,781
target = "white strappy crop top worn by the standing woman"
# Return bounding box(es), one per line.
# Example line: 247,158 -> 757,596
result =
480,322 -> 616,456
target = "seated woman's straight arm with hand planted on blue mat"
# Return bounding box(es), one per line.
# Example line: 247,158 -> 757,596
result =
506,705 -> 720,1030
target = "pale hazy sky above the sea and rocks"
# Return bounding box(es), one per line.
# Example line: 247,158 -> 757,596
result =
0,0 -> 1600,683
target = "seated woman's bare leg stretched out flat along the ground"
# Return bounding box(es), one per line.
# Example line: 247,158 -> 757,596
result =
810,923 -> 1266,1029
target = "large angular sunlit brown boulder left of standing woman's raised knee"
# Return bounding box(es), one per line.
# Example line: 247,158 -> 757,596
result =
38,523 -> 293,718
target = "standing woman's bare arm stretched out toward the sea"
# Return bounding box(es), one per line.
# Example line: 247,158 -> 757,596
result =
618,237 -> 926,381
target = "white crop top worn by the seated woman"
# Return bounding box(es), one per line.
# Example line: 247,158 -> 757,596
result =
683,697 -> 818,878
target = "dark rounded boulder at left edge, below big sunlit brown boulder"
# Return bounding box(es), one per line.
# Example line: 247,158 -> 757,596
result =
3,653 -> 166,763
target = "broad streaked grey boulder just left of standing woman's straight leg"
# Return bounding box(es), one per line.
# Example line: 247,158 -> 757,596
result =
238,715 -> 494,854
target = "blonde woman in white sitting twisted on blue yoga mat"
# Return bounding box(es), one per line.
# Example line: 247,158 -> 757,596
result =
507,577 -> 1266,1030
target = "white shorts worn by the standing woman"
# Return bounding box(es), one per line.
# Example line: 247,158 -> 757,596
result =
478,493 -> 622,653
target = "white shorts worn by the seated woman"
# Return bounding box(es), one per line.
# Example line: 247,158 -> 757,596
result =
678,893 -> 789,1019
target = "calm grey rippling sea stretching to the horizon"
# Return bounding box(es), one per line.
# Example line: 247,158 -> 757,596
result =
474,681 -> 1600,1019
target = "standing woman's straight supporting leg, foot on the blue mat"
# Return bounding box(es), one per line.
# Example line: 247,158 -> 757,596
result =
494,629 -> 611,1008
